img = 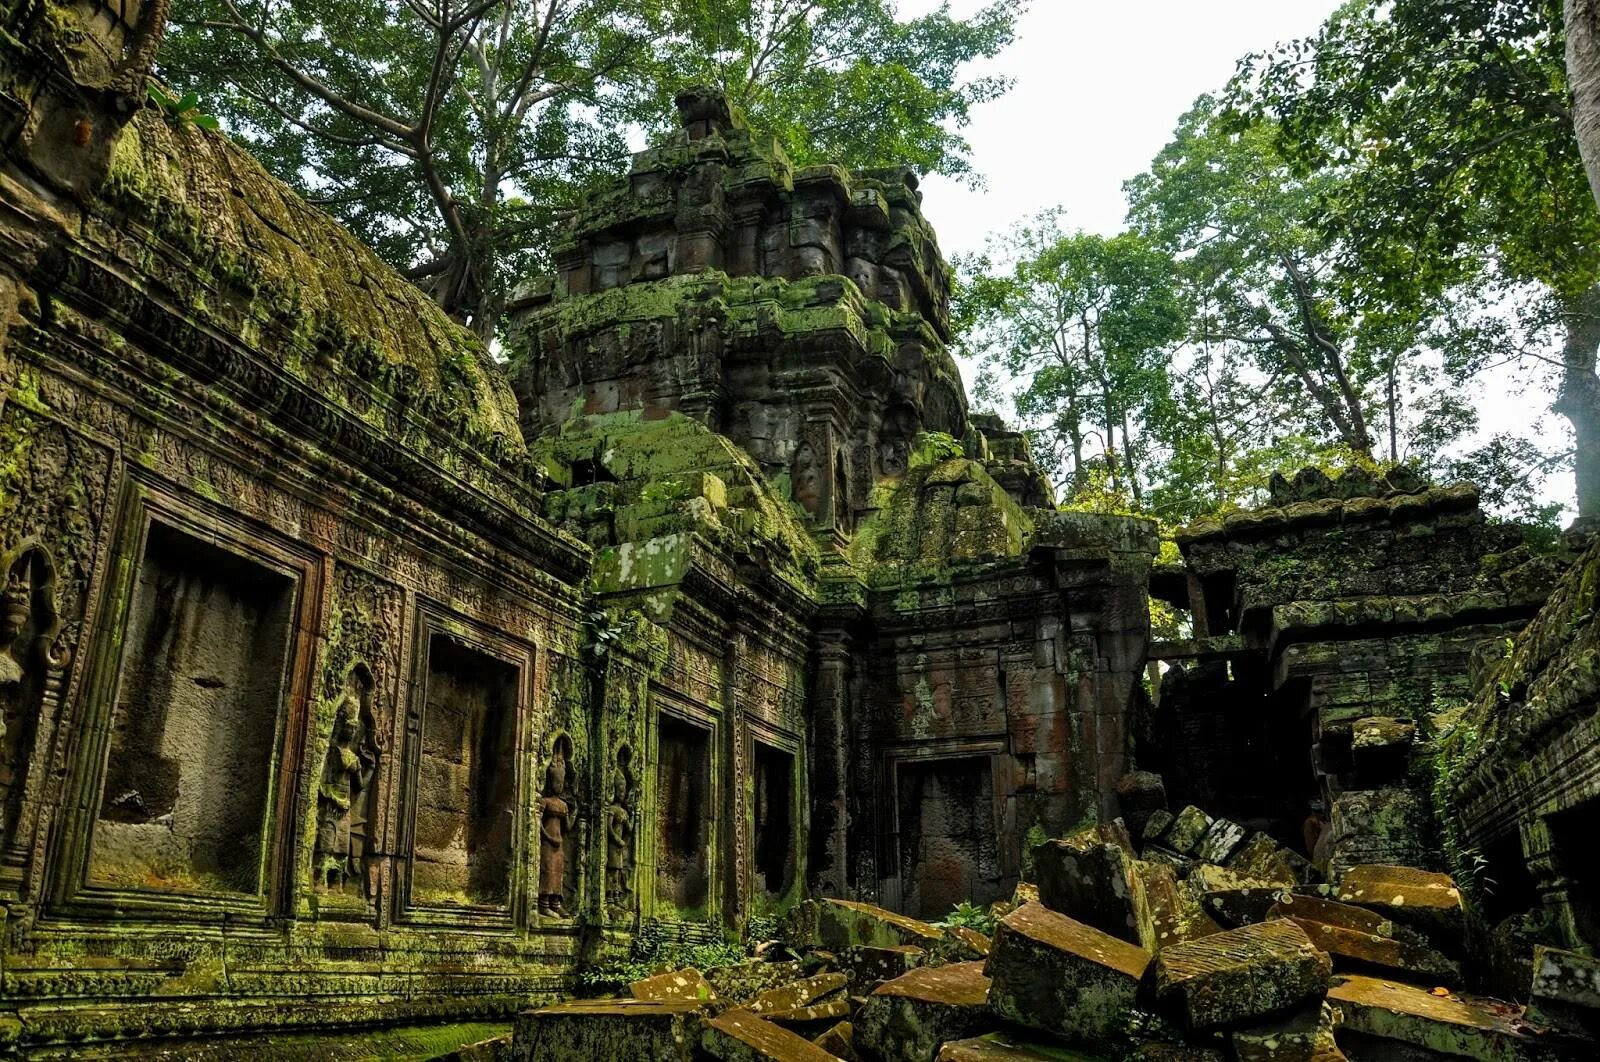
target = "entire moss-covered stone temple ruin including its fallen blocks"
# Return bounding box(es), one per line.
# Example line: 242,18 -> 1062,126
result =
0,0 -> 1600,1060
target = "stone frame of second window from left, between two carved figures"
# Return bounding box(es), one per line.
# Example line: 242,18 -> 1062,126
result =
390,595 -> 542,932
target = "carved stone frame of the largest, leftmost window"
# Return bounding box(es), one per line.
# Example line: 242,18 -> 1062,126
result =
46,467 -> 323,931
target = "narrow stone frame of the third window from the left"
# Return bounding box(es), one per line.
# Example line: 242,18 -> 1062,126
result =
634,683 -> 731,926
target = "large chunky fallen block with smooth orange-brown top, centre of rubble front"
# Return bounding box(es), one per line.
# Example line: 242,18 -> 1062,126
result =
987,904 -> 1150,1043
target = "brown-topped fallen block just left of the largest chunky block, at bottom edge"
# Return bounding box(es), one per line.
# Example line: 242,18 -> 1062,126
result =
854,963 -> 994,1062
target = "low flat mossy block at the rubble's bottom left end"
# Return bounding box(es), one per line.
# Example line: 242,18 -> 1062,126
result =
510,1000 -> 704,1062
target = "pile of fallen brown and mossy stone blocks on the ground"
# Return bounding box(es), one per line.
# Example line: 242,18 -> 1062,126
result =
509,808 -> 1600,1062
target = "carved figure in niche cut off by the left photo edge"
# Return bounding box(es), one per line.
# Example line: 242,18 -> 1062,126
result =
0,541 -> 61,844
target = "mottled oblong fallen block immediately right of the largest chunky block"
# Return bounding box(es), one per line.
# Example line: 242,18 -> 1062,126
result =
1154,918 -> 1330,1028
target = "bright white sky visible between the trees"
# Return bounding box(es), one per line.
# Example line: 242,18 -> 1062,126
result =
899,0 -> 1573,505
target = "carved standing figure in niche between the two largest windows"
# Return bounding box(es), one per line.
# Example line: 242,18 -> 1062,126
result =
314,664 -> 378,899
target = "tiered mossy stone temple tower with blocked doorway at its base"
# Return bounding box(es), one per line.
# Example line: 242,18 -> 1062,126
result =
510,90 -> 1155,915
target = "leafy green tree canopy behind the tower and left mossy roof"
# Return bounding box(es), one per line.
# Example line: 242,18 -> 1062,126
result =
158,0 -> 1024,337
